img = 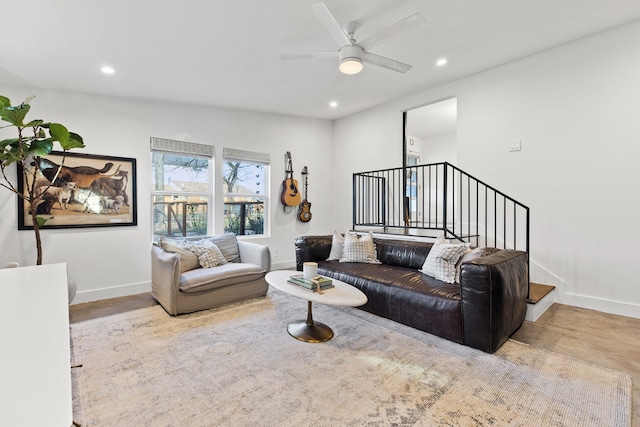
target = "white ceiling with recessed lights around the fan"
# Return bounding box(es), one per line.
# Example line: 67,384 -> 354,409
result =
5,0 -> 640,119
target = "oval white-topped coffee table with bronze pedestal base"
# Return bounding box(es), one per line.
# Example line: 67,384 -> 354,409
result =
265,270 -> 367,343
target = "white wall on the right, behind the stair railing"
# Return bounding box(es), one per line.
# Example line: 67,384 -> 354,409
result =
334,22 -> 640,317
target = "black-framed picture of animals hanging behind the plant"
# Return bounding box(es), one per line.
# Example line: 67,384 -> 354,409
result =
17,151 -> 138,230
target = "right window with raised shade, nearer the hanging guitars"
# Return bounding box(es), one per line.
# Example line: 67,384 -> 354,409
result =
223,148 -> 270,235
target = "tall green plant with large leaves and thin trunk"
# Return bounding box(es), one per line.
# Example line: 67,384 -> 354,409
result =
0,95 -> 84,265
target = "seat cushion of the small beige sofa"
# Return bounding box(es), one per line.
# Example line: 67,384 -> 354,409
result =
178,262 -> 267,292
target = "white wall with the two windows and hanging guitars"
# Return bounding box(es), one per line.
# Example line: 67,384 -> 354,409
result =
0,86 -> 333,303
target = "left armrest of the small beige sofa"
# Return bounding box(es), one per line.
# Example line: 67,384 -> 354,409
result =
151,245 -> 180,315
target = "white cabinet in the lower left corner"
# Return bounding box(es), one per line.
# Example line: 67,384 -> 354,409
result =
0,264 -> 73,427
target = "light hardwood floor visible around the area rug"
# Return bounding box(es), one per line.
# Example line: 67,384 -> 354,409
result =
70,294 -> 640,427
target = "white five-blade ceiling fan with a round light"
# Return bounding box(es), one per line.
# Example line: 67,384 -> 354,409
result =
280,2 -> 425,78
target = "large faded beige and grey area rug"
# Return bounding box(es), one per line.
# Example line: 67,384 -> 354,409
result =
71,291 -> 631,427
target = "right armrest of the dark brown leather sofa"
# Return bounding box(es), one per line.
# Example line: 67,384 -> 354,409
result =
460,249 -> 529,353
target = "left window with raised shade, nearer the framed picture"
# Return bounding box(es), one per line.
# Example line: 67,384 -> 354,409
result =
151,138 -> 215,241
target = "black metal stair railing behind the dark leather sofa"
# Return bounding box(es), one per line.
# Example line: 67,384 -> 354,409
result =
353,162 -> 529,254
